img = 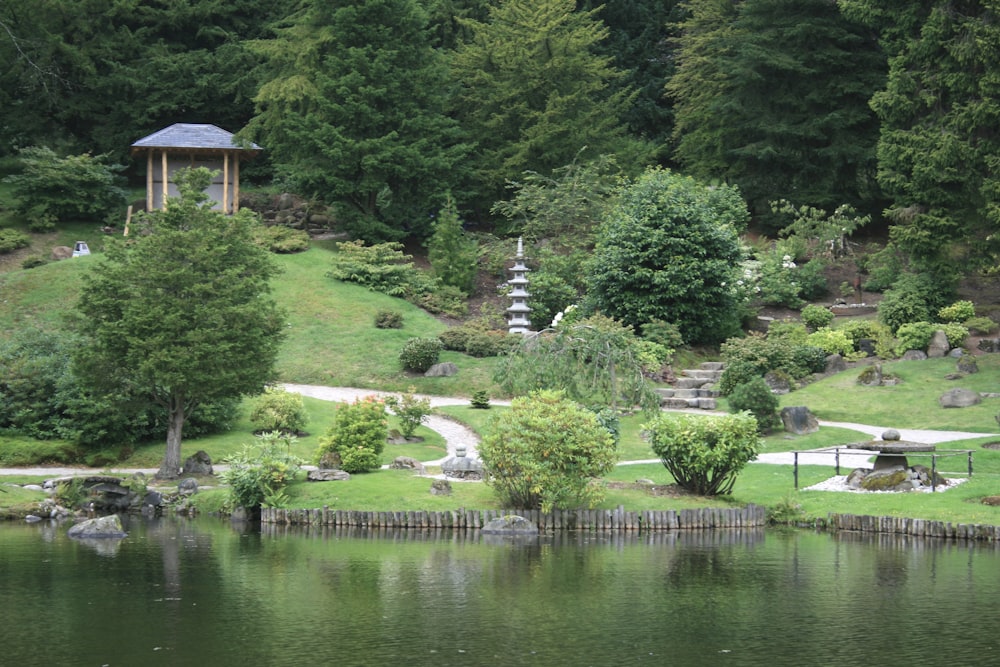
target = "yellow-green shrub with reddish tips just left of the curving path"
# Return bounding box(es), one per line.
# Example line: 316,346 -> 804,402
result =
315,396 -> 389,473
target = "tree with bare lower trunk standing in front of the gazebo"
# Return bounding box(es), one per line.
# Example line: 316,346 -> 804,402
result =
76,168 -> 284,479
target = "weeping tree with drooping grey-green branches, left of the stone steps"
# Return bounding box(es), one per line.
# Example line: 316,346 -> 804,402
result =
494,315 -> 667,410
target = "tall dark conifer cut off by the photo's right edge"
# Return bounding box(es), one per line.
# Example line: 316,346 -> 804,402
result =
843,0 -> 1000,276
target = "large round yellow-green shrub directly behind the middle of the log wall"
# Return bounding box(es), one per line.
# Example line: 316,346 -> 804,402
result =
479,391 -> 617,512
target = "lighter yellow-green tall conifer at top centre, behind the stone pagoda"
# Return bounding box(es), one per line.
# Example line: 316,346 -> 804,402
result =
452,0 -> 650,207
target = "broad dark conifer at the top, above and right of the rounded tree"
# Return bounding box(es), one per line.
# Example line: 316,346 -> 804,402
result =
667,0 -> 885,223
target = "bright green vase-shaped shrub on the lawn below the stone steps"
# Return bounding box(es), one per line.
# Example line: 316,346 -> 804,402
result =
643,412 -> 761,496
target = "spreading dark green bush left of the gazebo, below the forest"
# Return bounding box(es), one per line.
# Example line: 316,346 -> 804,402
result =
4,147 -> 126,223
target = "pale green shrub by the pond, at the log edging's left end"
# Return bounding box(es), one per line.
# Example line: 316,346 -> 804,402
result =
219,433 -> 302,510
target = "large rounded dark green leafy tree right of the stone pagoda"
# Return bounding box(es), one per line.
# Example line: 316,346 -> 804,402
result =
587,169 -> 748,344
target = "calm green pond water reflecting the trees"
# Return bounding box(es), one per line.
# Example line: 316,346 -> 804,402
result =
0,519 -> 1000,667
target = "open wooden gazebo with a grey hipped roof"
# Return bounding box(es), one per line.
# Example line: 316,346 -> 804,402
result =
132,123 -> 261,213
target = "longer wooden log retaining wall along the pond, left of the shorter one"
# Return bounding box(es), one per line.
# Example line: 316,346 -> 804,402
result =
260,505 -> 767,532
